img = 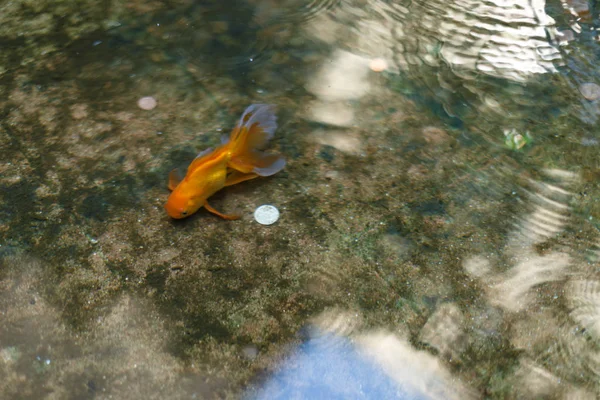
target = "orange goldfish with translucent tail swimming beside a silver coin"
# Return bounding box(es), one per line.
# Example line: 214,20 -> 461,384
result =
165,104 -> 285,220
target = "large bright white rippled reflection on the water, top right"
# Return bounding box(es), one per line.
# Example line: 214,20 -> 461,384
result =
342,0 -> 562,81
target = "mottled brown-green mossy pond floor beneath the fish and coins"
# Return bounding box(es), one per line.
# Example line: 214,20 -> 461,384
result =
0,0 -> 600,399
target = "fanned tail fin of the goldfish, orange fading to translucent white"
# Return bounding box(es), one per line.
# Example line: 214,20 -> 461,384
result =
228,104 -> 285,176
